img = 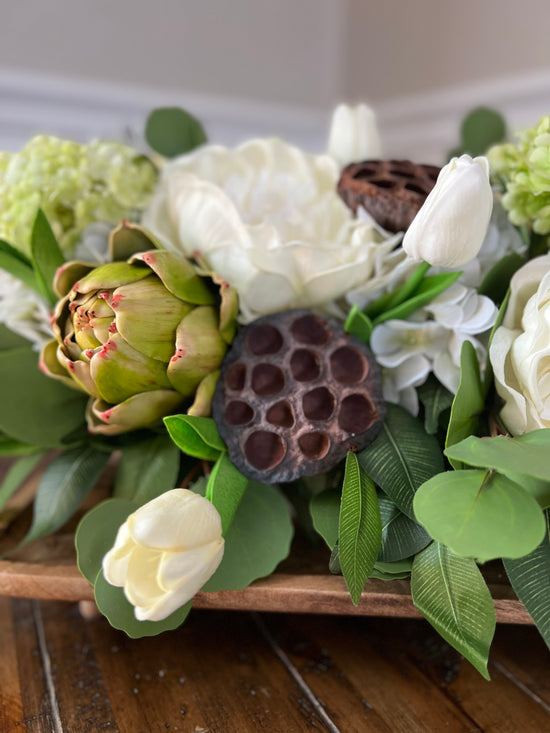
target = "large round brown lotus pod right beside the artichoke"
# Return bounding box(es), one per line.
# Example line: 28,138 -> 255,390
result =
212,310 -> 385,483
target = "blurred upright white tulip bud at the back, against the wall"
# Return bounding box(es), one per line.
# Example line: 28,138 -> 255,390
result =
328,104 -> 382,168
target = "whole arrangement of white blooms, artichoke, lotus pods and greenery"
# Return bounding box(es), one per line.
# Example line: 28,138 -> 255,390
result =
0,105 -> 550,677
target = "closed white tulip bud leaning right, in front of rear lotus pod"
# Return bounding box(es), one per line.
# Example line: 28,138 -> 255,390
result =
403,155 -> 493,267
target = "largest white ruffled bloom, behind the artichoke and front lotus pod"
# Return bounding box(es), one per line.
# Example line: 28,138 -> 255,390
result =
143,140 -> 405,322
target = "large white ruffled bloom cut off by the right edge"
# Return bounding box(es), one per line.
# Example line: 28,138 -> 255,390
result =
489,254 -> 550,435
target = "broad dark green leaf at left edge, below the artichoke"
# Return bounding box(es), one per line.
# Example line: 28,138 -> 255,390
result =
0,347 -> 87,448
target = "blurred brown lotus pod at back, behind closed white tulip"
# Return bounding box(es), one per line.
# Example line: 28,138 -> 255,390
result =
338,160 -> 440,232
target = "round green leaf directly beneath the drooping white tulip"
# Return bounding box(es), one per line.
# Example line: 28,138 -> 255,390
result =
94,571 -> 192,639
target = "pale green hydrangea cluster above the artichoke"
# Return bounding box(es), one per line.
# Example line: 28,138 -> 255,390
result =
0,135 -> 157,254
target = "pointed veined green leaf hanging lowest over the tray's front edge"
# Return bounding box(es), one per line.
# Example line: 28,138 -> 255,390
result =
411,542 -> 496,679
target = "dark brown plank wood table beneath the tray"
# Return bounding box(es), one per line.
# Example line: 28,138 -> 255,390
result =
0,597 -> 550,733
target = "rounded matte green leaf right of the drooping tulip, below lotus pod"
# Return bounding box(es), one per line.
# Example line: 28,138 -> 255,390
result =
202,481 -> 293,591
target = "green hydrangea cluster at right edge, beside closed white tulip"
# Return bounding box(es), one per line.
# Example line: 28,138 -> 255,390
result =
488,116 -> 550,234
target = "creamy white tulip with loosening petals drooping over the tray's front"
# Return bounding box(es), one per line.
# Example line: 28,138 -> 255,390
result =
103,489 -> 224,621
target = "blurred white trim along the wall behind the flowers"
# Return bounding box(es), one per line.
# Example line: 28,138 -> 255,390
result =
0,68 -> 550,163
